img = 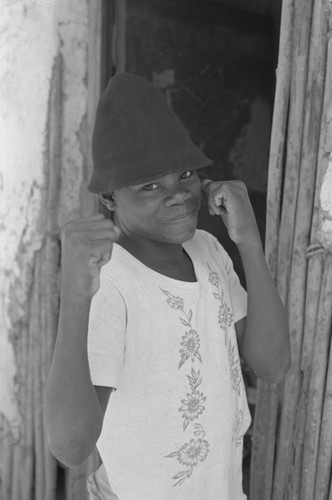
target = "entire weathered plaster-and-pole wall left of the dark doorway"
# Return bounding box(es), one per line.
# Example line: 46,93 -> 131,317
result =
0,0 -> 100,500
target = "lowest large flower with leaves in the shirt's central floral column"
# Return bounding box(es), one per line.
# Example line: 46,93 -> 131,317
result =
166,424 -> 209,486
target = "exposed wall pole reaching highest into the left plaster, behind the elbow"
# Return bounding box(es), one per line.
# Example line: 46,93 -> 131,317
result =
40,48 -> 63,500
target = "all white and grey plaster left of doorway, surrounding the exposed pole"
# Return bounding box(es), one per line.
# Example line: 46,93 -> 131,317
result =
0,0 -> 88,434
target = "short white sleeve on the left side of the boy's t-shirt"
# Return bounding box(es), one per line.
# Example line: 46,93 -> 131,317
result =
88,272 -> 127,389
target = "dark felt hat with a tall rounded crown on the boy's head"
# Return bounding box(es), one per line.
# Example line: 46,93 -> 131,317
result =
88,73 -> 211,194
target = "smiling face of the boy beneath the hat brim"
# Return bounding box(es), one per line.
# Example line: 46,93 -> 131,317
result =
113,170 -> 202,244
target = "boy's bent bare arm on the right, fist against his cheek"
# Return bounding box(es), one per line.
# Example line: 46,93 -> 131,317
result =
203,181 -> 290,383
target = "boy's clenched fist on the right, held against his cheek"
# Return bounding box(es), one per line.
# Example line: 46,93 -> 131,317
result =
202,179 -> 261,245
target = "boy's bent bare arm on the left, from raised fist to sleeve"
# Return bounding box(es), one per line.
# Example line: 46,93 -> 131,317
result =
45,214 -> 118,467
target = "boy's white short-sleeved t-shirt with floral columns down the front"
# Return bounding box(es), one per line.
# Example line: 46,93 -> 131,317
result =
88,230 -> 250,500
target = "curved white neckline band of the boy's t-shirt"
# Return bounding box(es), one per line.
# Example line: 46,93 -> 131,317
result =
113,240 -> 200,289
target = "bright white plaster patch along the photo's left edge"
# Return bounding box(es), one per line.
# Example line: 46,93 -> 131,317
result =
0,0 -> 57,436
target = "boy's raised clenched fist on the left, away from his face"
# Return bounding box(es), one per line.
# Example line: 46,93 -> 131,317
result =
61,214 -> 120,298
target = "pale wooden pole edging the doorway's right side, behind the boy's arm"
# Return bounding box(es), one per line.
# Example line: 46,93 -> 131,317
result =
250,0 -> 294,500
